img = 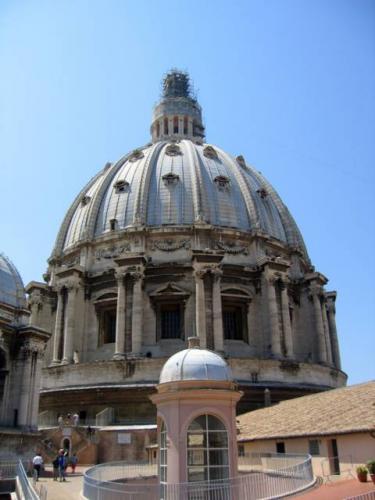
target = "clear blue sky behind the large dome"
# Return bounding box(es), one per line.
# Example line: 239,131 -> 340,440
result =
0,0 -> 375,383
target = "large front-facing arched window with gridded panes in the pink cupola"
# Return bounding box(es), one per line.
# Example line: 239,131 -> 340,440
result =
187,415 -> 229,482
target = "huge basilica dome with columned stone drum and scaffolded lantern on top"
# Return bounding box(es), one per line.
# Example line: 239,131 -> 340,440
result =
36,70 -> 346,430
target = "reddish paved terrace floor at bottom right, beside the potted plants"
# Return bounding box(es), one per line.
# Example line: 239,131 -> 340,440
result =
293,479 -> 375,500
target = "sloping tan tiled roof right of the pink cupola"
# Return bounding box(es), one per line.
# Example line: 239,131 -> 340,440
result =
237,381 -> 375,441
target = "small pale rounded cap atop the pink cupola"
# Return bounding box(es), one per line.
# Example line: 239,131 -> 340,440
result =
159,347 -> 233,384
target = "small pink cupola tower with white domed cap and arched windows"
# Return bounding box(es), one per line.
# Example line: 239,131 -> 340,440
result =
151,337 -> 242,487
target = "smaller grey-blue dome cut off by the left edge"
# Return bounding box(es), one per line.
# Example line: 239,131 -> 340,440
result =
0,253 -> 26,307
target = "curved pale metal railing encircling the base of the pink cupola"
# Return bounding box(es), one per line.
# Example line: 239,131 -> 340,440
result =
83,453 -> 315,500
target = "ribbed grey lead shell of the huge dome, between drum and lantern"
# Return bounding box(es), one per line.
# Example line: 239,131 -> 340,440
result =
54,139 -> 306,255
